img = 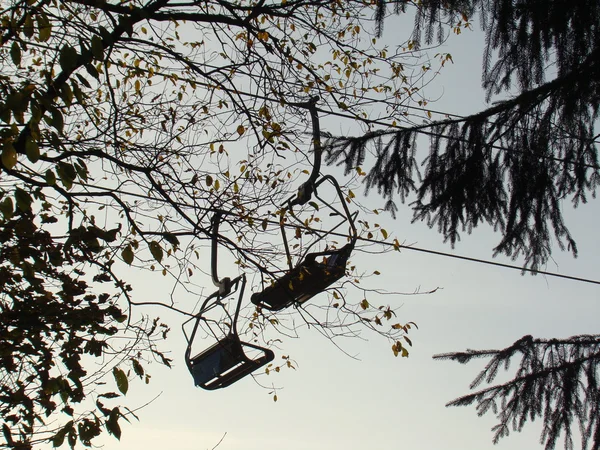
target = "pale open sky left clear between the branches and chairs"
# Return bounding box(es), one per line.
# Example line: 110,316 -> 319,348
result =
91,9 -> 600,450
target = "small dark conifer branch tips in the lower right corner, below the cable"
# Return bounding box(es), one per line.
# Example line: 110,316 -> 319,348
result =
434,335 -> 600,450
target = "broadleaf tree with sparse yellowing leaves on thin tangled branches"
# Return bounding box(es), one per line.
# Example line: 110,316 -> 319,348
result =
0,0 -> 432,448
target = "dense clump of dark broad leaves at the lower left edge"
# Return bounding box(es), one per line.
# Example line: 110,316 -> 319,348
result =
0,210 -> 168,447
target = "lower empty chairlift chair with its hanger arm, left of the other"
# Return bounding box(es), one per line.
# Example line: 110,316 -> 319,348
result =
182,212 -> 275,390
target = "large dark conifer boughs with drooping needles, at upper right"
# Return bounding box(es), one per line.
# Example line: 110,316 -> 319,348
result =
328,0 -> 600,270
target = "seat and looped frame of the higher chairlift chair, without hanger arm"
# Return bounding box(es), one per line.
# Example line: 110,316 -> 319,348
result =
250,175 -> 357,311
